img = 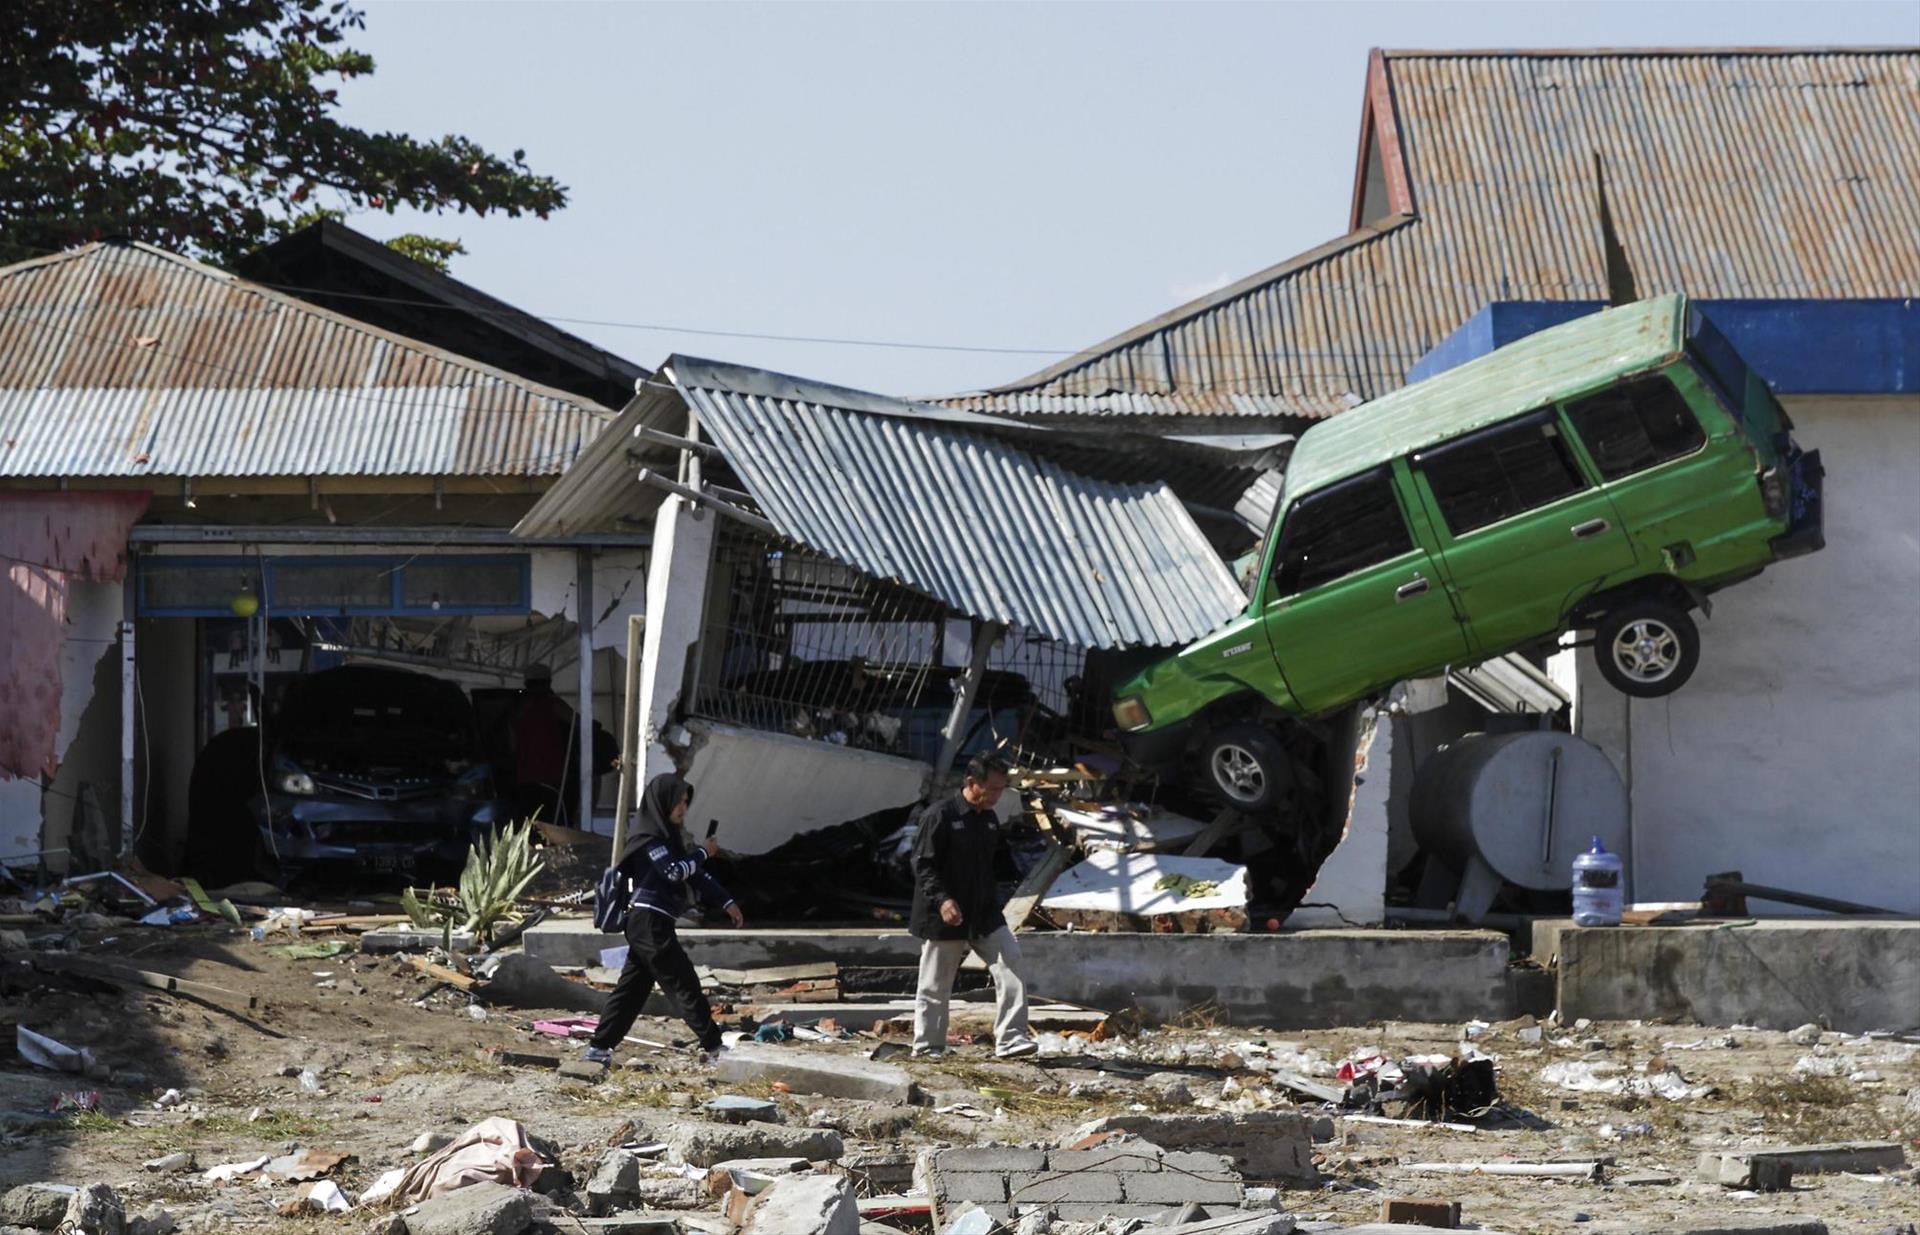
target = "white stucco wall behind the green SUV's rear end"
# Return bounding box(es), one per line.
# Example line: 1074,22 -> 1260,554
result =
1580,396 -> 1920,912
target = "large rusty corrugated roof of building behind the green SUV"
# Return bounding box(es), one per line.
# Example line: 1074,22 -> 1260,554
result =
960,48 -> 1920,419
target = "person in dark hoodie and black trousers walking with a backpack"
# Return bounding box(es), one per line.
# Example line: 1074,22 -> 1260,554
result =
588,772 -> 745,1064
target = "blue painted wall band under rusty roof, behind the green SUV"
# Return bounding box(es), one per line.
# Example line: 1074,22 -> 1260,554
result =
1407,300 -> 1920,394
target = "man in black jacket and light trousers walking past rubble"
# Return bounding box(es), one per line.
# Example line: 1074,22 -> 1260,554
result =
910,755 -> 1039,1058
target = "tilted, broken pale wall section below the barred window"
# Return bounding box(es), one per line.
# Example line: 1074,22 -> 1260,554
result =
687,720 -> 933,853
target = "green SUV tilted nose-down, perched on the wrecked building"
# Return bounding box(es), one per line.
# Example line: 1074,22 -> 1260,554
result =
1114,296 -> 1824,811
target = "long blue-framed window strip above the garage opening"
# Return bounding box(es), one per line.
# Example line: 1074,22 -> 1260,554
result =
138,553 -> 532,617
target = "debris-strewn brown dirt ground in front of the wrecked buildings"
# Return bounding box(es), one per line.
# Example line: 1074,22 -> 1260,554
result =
0,922 -> 1920,1235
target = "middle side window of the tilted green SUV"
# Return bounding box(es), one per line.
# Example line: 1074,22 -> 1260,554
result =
1413,407 -> 1586,536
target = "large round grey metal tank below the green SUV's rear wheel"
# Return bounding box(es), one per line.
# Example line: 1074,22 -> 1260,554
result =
1409,730 -> 1628,920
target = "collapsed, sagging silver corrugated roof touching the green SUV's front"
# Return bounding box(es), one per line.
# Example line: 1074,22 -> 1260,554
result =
666,357 -> 1246,647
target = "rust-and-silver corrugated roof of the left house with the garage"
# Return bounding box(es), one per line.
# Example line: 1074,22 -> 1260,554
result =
0,244 -> 612,476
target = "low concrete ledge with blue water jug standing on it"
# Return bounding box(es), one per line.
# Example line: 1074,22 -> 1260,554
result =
1532,918 -> 1920,1033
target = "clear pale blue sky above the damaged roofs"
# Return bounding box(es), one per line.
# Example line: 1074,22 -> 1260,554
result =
342,0 -> 1920,394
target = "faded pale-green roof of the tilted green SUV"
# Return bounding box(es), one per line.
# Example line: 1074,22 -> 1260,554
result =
1286,296 -> 1686,503
